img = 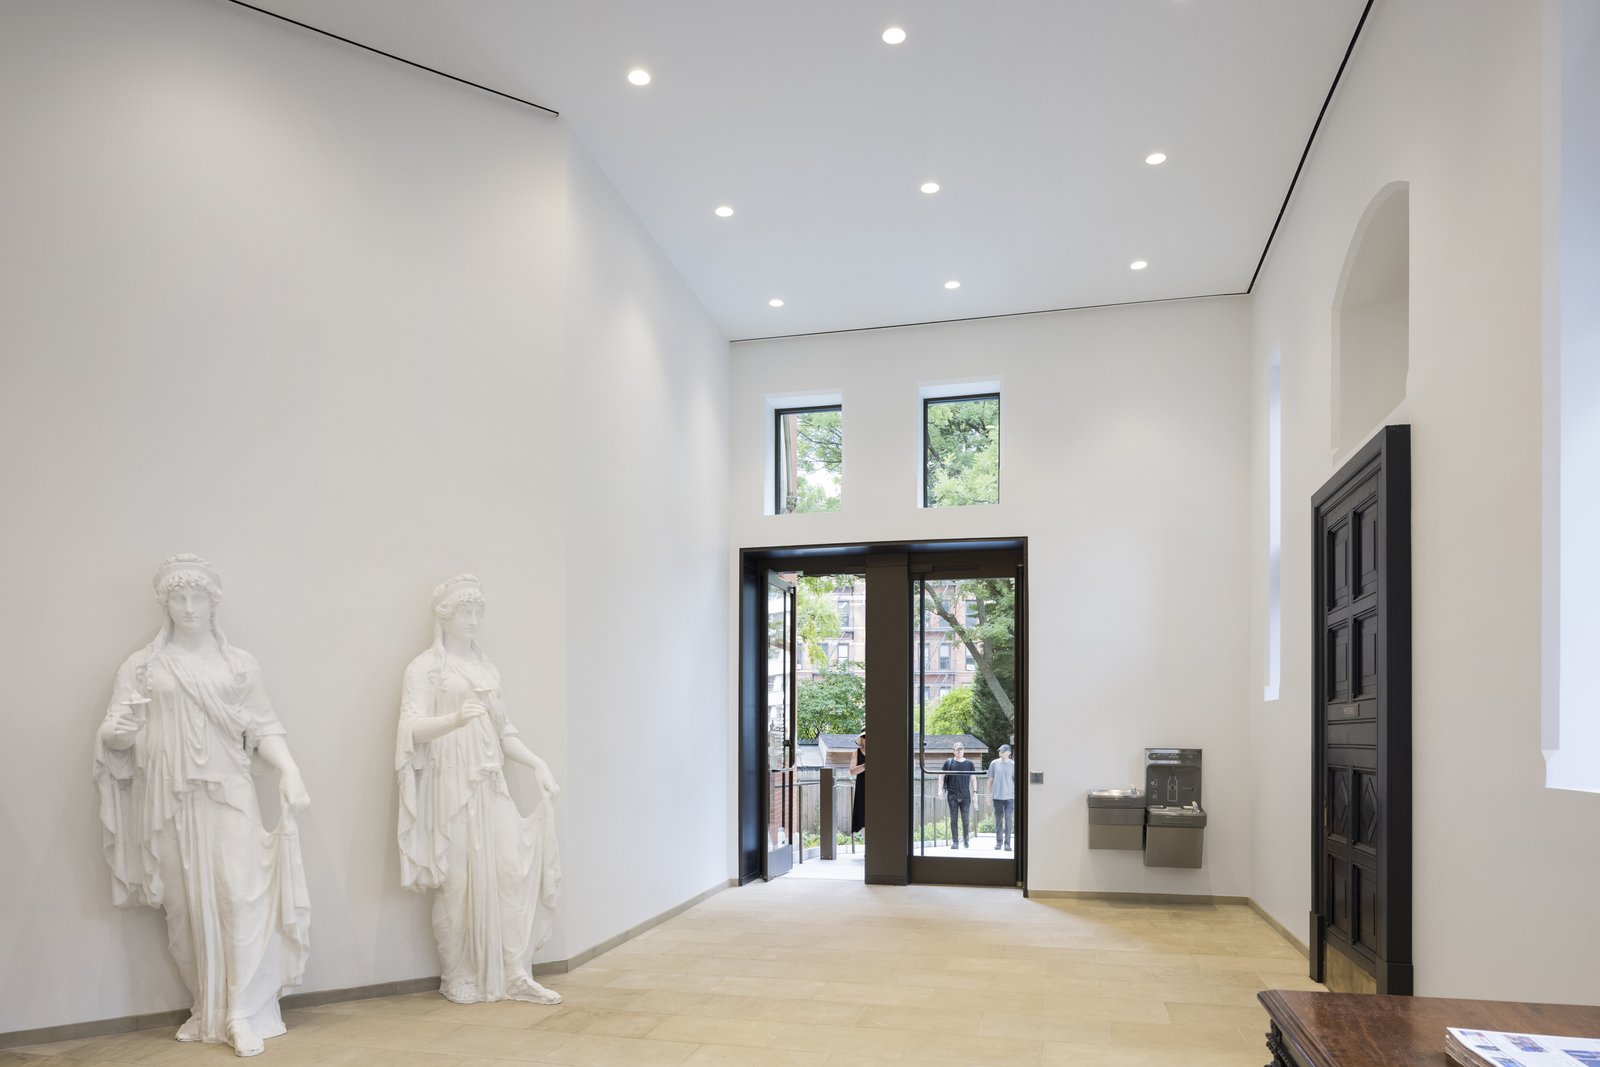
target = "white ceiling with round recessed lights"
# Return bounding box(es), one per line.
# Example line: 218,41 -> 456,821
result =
236,0 -> 1363,339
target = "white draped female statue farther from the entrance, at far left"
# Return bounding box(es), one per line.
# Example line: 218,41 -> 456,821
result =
94,555 -> 310,1056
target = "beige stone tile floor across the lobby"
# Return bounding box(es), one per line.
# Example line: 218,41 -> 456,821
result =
0,878 -> 1320,1067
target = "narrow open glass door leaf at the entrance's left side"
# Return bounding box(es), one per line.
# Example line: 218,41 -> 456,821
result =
762,571 -> 798,881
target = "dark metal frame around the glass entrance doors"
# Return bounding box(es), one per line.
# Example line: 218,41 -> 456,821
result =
736,537 -> 1027,893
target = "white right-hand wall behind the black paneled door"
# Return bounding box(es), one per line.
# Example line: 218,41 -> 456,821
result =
1250,0 -> 1600,1003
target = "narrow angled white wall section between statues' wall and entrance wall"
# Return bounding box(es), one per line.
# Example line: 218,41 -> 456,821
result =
565,141 -> 733,953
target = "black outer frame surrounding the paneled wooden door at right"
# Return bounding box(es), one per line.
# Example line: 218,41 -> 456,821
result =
1310,426 -> 1413,995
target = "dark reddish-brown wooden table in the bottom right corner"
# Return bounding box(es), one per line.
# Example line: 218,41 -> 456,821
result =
1256,989 -> 1600,1067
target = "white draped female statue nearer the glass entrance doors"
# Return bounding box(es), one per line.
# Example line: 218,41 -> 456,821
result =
395,574 -> 562,1005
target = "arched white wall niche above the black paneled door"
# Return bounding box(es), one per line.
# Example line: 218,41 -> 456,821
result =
1330,181 -> 1411,454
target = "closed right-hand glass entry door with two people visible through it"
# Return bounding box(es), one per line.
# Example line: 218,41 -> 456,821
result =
909,568 -> 1022,885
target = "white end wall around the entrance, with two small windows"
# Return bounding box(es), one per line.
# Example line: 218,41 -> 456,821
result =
730,299 -> 1254,896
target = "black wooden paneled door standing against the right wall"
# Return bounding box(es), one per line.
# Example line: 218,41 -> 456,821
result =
1310,426 -> 1411,993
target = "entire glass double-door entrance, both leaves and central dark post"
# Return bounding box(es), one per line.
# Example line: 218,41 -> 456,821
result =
738,537 -> 1029,886
